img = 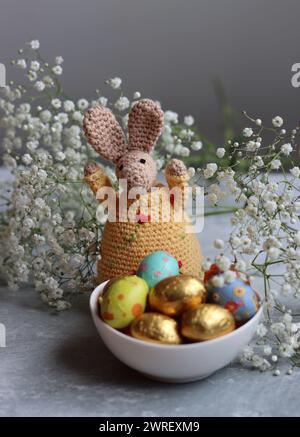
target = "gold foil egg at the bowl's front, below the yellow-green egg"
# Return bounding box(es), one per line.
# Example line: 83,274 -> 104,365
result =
130,313 -> 182,344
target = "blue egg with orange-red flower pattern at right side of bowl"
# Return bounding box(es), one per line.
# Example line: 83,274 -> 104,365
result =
208,278 -> 259,322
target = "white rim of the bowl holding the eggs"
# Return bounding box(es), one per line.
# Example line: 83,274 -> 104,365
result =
89,280 -> 264,350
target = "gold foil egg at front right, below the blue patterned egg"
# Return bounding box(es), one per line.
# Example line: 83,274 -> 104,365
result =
181,304 -> 235,341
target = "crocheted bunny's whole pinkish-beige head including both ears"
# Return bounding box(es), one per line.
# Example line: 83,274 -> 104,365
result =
83,99 -> 163,191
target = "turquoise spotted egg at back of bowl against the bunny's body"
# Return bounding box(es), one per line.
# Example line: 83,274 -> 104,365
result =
137,250 -> 179,288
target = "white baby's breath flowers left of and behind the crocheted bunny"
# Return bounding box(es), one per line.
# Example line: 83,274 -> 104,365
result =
0,40 -> 194,310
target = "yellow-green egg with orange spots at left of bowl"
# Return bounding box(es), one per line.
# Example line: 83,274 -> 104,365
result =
99,275 -> 149,329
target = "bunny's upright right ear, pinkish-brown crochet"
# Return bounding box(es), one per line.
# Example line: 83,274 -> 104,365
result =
128,99 -> 164,152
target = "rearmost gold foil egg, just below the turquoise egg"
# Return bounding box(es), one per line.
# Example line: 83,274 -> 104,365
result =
149,275 -> 207,317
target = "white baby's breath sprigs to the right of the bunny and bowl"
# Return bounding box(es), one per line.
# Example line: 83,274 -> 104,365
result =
198,113 -> 300,376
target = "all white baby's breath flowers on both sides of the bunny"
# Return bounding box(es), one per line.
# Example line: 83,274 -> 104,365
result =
0,40 -> 300,375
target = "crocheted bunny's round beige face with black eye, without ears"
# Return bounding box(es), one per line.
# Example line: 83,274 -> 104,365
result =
116,150 -> 157,191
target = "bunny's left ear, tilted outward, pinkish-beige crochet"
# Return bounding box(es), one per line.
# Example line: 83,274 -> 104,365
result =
83,106 -> 126,163
